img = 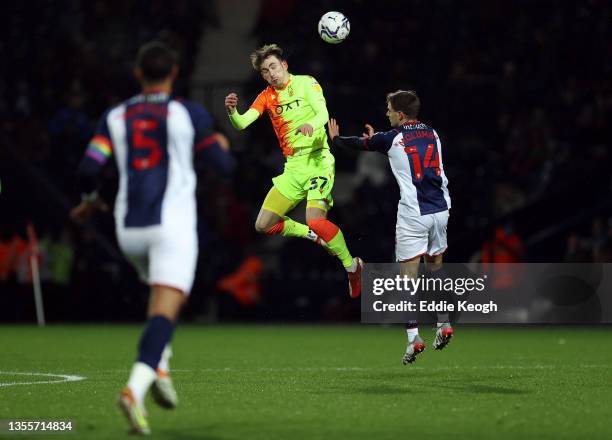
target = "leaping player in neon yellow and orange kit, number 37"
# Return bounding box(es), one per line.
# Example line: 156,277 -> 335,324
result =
225,44 -> 363,298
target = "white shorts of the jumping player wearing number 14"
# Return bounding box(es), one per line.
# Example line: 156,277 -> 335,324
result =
395,210 -> 449,261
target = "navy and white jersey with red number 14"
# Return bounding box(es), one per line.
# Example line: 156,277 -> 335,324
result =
365,121 -> 451,216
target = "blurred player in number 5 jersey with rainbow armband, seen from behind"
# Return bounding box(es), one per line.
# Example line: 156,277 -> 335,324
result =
71,42 -> 233,434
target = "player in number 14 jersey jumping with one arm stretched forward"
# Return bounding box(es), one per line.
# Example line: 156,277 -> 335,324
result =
328,90 -> 453,364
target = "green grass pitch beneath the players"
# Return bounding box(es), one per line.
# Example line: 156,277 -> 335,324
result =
0,325 -> 612,440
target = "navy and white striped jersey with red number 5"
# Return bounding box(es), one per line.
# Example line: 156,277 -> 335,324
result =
74,92 -> 233,228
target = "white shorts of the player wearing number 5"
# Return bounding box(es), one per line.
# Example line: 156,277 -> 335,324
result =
117,225 -> 198,295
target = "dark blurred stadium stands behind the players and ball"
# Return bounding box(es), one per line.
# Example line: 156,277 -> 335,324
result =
0,0 -> 612,322
